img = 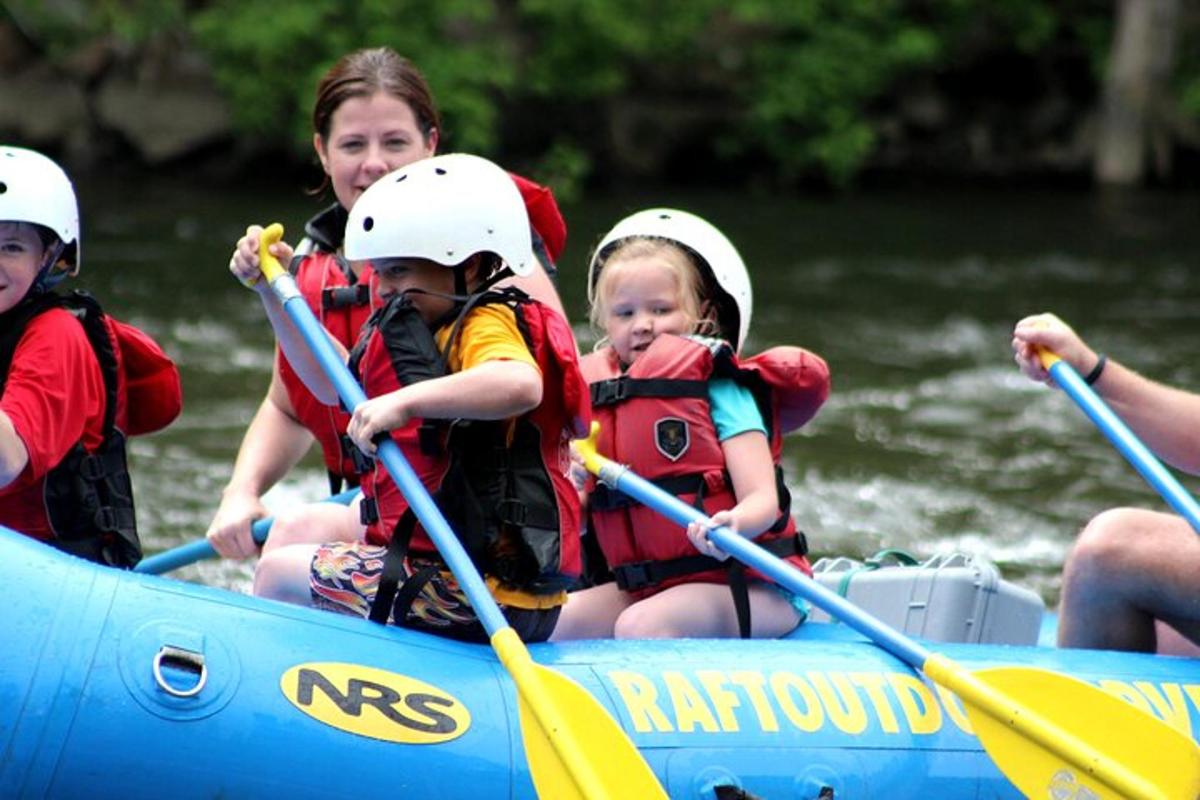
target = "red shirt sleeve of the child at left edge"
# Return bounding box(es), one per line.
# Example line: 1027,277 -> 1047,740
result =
0,309 -> 104,488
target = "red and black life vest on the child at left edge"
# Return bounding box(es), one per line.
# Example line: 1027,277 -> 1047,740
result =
0,291 -> 184,567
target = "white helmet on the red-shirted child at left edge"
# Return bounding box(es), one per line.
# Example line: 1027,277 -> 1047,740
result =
0,146 -> 79,275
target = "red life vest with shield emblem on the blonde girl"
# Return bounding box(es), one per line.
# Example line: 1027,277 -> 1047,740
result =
581,335 -> 829,597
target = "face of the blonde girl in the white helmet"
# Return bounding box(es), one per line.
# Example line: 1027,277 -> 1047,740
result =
604,255 -> 696,365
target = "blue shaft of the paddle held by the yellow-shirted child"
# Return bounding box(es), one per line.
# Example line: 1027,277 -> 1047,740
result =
271,272 -> 508,636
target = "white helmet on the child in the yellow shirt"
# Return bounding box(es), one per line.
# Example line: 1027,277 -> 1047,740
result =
343,154 -> 536,275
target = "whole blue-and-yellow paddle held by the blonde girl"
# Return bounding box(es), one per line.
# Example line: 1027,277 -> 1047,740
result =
575,423 -> 1200,800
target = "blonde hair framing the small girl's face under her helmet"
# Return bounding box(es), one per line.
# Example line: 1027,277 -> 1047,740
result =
588,236 -> 719,350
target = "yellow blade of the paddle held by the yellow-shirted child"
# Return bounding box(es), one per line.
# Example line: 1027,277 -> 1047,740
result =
492,627 -> 667,800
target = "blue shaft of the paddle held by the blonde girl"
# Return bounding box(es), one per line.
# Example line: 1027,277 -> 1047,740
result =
599,462 -> 930,669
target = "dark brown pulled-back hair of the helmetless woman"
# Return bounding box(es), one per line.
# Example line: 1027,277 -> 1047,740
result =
312,47 -> 442,140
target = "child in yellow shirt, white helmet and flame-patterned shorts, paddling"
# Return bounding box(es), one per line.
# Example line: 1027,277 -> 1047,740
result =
233,155 -> 589,640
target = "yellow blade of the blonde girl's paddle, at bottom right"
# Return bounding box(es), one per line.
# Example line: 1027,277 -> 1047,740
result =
954,667 -> 1200,800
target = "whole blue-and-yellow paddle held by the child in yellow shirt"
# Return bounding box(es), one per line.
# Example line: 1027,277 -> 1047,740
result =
259,223 -> 667,800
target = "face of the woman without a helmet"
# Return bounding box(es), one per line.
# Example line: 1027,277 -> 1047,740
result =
313,91 -> 438,210
